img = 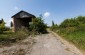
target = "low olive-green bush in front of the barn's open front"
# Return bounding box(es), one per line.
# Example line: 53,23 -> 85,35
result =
10,28 -> 30,40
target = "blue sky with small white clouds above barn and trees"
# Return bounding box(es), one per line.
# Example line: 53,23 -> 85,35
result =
0,0 -> 85,26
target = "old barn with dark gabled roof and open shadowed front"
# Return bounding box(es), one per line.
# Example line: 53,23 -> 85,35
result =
12,11 -> 35,32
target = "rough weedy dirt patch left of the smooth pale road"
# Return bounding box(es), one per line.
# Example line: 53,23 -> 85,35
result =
0,37 -> 34,55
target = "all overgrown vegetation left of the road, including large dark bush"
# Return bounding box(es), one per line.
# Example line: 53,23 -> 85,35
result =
0,17 -> 47,45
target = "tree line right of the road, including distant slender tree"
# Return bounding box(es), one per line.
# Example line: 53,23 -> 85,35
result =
51,16 -> 85,31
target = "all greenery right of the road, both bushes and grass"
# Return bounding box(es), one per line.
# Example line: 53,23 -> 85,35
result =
51,16 -> 85,50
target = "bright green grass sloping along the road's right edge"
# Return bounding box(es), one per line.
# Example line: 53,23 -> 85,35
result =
58,31 -> 85,50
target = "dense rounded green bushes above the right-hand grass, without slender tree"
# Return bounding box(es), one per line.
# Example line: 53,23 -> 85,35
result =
59,16 -> 85,31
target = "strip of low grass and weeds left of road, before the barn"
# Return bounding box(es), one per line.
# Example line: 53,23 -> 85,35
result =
0,30 -> 29,46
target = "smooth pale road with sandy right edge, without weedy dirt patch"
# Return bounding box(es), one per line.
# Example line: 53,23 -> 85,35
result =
30,33 -> 83,55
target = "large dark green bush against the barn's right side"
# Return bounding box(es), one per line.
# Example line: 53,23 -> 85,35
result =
30,17 -> 47,33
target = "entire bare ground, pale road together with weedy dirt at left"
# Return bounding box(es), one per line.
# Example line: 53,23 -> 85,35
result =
0,33 -> 83,55
